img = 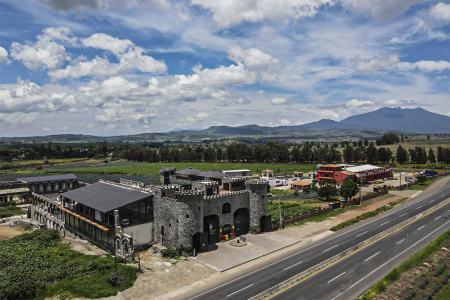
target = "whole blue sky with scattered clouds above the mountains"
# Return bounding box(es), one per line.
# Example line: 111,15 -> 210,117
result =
0,0 -> 450,136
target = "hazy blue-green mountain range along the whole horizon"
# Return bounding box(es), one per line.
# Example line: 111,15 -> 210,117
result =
0,107 -> 450,143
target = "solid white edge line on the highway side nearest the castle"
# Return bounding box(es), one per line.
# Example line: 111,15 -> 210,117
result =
189,186 -> 450,300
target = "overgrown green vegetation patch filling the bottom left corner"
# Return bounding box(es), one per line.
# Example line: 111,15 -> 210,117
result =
0,230 -> 137,299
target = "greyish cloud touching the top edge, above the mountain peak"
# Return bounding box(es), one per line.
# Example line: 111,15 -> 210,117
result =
340,0 -> 424,21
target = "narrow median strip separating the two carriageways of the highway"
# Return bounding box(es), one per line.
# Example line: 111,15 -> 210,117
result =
250,198 -> 450,300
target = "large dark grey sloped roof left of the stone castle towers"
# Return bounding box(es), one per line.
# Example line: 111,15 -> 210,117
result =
61,182 -> 151,212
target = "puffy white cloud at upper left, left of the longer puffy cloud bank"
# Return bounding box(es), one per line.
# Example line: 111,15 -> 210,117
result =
11,27 -> 76,71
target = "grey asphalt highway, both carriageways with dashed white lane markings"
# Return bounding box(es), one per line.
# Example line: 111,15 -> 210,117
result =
182,188 -> 450,300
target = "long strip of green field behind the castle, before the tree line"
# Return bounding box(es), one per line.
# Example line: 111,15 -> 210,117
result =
13,162 -> 317,175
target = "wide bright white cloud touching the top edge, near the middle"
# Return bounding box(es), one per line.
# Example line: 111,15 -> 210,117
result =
191,0 -> 333,27
